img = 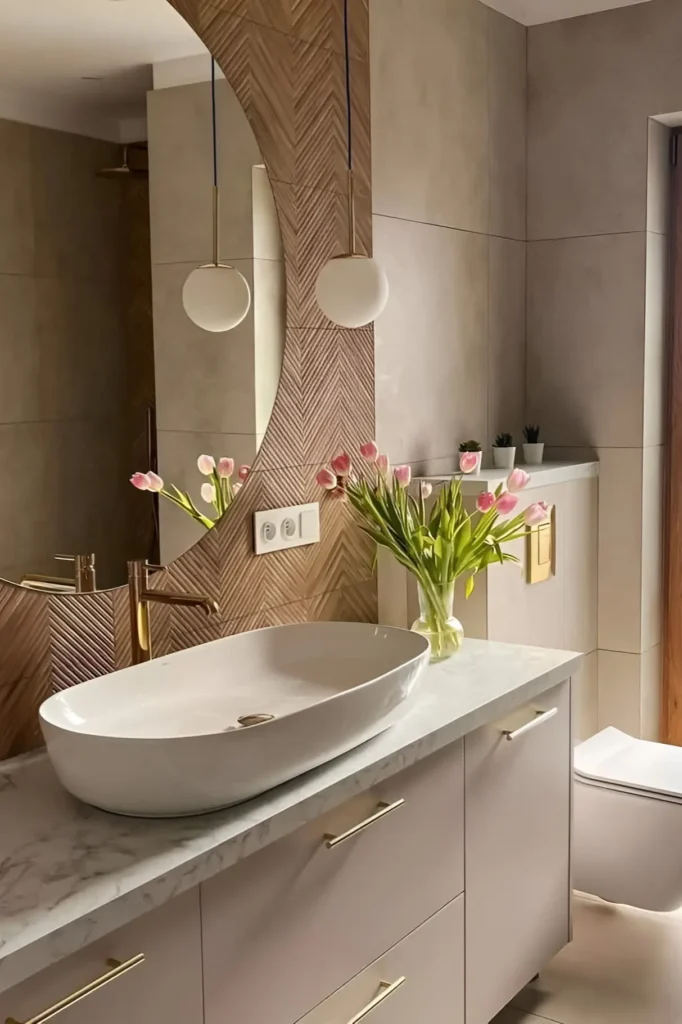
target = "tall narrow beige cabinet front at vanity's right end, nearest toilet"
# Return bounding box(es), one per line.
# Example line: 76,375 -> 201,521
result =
464,682 -> 572,1024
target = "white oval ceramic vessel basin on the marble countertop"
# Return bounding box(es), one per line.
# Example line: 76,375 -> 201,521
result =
40,623 -> 429,817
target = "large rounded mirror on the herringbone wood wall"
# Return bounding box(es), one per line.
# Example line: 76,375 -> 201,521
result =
0,0 -> 286,591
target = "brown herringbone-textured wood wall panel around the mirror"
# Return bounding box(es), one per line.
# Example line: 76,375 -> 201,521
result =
0,0 -> 376,758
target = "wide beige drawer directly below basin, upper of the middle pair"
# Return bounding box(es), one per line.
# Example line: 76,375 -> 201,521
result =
202,743 -> 464,1024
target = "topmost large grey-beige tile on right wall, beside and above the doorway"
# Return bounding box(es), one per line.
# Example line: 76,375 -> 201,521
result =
528,0 -> 682,239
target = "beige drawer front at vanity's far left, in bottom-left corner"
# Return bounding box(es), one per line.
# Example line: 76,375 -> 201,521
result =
0,889 -> 204,1024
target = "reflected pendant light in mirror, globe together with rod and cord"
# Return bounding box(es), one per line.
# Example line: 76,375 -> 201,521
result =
182,58 -> 251,333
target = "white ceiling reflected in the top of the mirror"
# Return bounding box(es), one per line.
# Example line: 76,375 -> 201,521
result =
0,0 -> 207,137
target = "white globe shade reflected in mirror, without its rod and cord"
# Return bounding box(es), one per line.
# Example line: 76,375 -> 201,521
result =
182,263 -> 251,333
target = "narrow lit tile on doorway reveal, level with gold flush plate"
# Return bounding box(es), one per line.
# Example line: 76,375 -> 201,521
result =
642,447 -> 665,651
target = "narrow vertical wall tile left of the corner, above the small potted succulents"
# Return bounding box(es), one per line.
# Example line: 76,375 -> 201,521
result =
487,238 -> 525,452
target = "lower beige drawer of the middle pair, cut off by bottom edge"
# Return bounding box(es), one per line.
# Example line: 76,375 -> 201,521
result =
300,896 -> 464,1024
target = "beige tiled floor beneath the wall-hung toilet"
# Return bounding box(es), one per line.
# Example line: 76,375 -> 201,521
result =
494,897 -> 682,1024
